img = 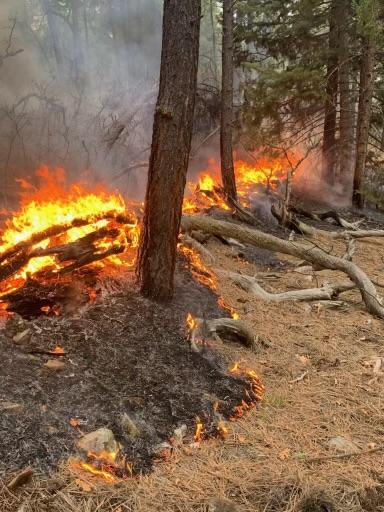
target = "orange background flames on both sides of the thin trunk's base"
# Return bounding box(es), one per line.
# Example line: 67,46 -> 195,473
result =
183,154 -> 297,213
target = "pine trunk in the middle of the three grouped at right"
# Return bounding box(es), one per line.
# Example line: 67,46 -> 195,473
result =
339,0 -> 354,187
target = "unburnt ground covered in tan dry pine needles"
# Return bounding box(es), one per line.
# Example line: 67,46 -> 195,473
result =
0,221 -> 384,512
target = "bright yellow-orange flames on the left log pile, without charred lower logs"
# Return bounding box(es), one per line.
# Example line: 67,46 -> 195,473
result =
0,166 -> 139,302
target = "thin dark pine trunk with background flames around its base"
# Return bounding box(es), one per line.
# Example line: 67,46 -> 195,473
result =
220,0 -> 237,200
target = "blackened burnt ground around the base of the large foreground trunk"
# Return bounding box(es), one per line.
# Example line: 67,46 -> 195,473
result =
0,256 -> 260,473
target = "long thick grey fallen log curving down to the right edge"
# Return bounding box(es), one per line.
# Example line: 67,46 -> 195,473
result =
181,215 -> 384,318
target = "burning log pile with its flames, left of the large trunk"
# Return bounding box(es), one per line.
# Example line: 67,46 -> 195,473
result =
0,166 -> 139,313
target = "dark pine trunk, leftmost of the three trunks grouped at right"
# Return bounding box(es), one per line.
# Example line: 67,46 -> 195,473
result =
322,0 -> 339,185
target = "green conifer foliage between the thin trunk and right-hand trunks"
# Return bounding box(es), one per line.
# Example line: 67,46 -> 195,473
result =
236,0 -> 328,143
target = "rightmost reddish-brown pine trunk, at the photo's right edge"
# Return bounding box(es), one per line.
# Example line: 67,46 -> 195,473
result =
352,37 -> 375,208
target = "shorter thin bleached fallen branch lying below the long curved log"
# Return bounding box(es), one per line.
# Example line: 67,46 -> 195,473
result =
214,269 -> 356,302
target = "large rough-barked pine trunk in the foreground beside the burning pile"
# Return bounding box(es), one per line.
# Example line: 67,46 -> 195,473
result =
137,0 -> 201,301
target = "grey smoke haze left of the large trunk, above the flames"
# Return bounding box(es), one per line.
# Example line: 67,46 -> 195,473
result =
0,0 -> 162,203
